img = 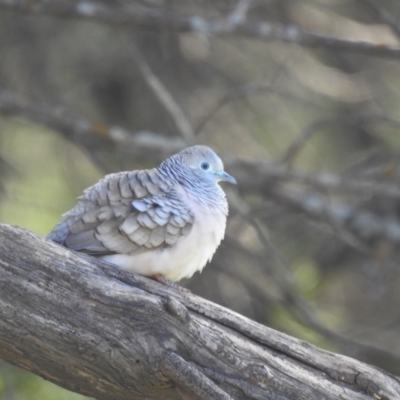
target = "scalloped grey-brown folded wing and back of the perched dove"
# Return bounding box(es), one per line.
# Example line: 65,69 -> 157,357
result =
47,169 -> 194,256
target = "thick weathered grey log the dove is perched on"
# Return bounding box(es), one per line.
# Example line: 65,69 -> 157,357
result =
0,225 -> 400,400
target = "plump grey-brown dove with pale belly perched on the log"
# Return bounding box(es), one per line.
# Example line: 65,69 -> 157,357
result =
47,145 -> 237,287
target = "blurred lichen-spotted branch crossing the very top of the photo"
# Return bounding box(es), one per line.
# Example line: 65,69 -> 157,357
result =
0,0 -> 400,58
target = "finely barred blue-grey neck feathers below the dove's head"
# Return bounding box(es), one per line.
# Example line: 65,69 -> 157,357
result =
157,154 -> 228,214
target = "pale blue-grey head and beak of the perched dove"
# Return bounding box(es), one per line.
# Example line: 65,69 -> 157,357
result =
178,146 -> 236,184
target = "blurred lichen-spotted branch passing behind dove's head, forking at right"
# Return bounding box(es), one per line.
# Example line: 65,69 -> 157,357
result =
0,91 -> 400,247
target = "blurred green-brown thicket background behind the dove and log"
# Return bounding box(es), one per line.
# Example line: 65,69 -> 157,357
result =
0,0 -> 400,400
